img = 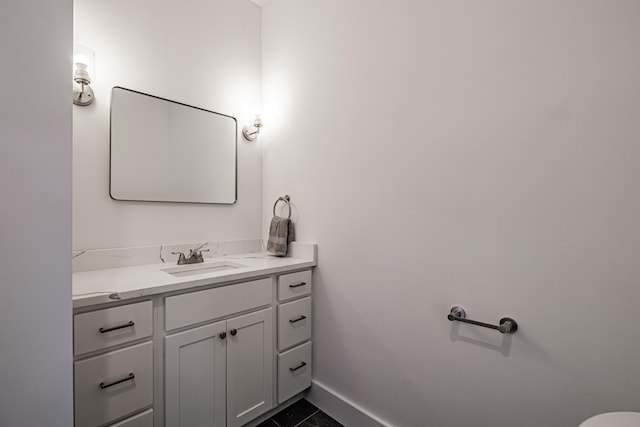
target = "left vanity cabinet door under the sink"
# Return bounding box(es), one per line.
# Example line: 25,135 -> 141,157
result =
165,321 -> 227,427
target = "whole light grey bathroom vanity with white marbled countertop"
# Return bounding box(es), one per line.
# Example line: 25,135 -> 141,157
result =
73,245 -> 316,427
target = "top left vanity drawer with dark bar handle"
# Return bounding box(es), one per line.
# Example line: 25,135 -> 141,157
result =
73,301 -> 153,356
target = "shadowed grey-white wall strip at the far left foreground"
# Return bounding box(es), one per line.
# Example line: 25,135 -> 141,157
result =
0,0 -> 73,427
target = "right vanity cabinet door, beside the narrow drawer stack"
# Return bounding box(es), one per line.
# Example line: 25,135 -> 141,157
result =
227,308 -> 273,427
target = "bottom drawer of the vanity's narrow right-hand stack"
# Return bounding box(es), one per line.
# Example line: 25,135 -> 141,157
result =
278,342 -> 311,403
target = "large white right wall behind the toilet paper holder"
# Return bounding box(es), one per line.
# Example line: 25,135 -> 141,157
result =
262,0 -> 640,427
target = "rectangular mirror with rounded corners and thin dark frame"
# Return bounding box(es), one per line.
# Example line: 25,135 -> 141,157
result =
109,87 -> 237,204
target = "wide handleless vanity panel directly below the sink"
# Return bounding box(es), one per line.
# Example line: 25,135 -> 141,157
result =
165,278 -> 273,331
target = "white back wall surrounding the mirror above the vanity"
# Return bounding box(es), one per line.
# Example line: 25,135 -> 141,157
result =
73,0 -> 262,250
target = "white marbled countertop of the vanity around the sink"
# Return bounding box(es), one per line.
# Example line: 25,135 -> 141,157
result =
72,249 -> 316,308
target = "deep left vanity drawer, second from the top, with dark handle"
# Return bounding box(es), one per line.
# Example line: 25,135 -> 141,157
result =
73,342 -> 153,427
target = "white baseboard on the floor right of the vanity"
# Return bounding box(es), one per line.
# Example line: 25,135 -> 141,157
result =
304,380 -> 394,427
